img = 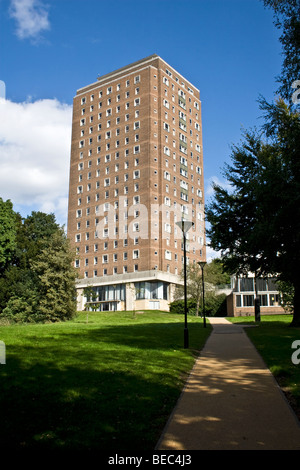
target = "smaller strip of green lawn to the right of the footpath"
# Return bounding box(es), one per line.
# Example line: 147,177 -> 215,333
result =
228,315 -> 300,419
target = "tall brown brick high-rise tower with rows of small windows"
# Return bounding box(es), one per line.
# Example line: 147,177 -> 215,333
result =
68,55 -> 206,311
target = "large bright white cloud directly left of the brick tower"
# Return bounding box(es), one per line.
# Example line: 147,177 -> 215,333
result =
0,99 -> 72,223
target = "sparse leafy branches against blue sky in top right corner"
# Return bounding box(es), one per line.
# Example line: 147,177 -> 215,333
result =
263,0 -> 300,102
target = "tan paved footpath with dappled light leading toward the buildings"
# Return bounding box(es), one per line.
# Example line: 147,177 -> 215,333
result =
156,318 -> 300,450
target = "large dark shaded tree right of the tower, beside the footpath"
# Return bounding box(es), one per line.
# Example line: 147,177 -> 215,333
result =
206,100 -> 300,325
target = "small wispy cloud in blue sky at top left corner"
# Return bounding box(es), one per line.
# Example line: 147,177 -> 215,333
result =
10,0 -> 50,39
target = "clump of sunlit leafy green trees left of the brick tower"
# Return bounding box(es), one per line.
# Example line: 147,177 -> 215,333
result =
0,204 -> 76,322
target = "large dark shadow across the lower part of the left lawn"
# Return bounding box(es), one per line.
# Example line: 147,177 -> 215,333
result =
0,355 -> 178,450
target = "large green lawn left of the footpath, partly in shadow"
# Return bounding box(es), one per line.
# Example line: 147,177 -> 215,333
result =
0,312 -> 211,451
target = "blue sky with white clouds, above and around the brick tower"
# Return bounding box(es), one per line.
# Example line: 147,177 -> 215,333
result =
0,0 -> 282,235
